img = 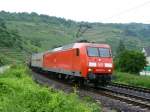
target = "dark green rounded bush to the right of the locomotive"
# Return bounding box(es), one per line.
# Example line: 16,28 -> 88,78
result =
117,50 -> 146,73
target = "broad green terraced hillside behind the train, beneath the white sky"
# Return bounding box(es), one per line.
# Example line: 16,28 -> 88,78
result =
0,11 -> 150,64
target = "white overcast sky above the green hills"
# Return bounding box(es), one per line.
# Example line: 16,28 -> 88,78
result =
0,0 -> 150,23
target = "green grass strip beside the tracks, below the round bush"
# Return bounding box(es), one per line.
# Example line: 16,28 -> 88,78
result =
113,72 -> 150,88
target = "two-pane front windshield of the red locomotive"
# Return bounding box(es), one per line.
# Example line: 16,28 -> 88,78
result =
87,47 -> 111,57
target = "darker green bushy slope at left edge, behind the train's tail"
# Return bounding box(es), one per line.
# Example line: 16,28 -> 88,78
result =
0,19 -> 37,65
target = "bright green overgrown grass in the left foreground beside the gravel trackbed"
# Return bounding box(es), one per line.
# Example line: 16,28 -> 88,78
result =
0,66 -> 100,112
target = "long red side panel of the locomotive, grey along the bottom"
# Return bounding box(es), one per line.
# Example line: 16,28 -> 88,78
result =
44,49 -> 81,76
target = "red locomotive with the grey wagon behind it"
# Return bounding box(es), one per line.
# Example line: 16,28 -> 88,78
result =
31,43 -> 113,84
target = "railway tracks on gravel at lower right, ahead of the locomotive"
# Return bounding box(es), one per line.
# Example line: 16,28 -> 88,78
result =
97,83 -> 150,110
